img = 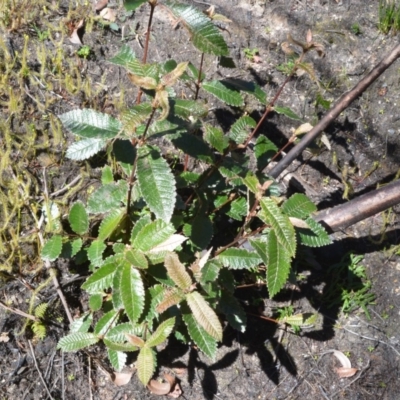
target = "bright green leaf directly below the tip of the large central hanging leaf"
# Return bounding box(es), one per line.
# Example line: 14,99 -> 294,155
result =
132,219 -> 175,252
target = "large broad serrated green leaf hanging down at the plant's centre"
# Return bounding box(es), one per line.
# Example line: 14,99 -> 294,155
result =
136,146 -> 176,222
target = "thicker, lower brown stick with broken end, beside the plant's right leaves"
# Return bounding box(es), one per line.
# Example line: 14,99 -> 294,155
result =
314,179 -> 400,232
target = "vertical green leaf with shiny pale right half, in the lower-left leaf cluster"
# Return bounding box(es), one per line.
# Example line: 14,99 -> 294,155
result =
121,263 -> 144,324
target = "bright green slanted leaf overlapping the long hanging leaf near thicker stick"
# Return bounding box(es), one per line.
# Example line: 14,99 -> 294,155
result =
258,197 -> 296,256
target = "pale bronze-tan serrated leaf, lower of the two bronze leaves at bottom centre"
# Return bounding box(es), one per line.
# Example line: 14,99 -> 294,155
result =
186,292 -> 222,341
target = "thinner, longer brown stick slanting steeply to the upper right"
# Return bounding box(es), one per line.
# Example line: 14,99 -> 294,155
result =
269,44 -> 400,178
